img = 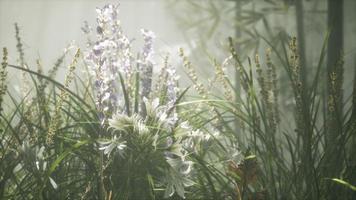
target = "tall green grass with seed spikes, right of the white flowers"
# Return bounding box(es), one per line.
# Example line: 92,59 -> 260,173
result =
178,37 -> 355,199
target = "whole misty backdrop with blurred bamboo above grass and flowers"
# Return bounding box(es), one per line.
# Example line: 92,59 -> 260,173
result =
0,0 -> 356,91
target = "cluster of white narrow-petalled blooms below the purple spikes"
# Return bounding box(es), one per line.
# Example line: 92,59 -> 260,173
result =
102,98 -> 200,198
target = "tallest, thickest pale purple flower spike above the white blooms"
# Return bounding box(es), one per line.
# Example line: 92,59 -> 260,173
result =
84,5 -> 133,123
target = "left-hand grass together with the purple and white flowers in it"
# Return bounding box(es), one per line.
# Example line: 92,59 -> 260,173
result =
0,5 -> 209,199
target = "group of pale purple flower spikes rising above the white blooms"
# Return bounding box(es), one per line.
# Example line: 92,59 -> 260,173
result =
85,5 -> 179,124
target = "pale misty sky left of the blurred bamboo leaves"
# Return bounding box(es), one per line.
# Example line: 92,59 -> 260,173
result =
0,0 -> 184,68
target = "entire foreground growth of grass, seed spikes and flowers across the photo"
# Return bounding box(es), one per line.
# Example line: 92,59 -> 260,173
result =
0,1 -> 356,200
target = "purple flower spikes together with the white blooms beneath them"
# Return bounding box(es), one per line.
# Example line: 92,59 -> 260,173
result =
83,5 -> 209,197
